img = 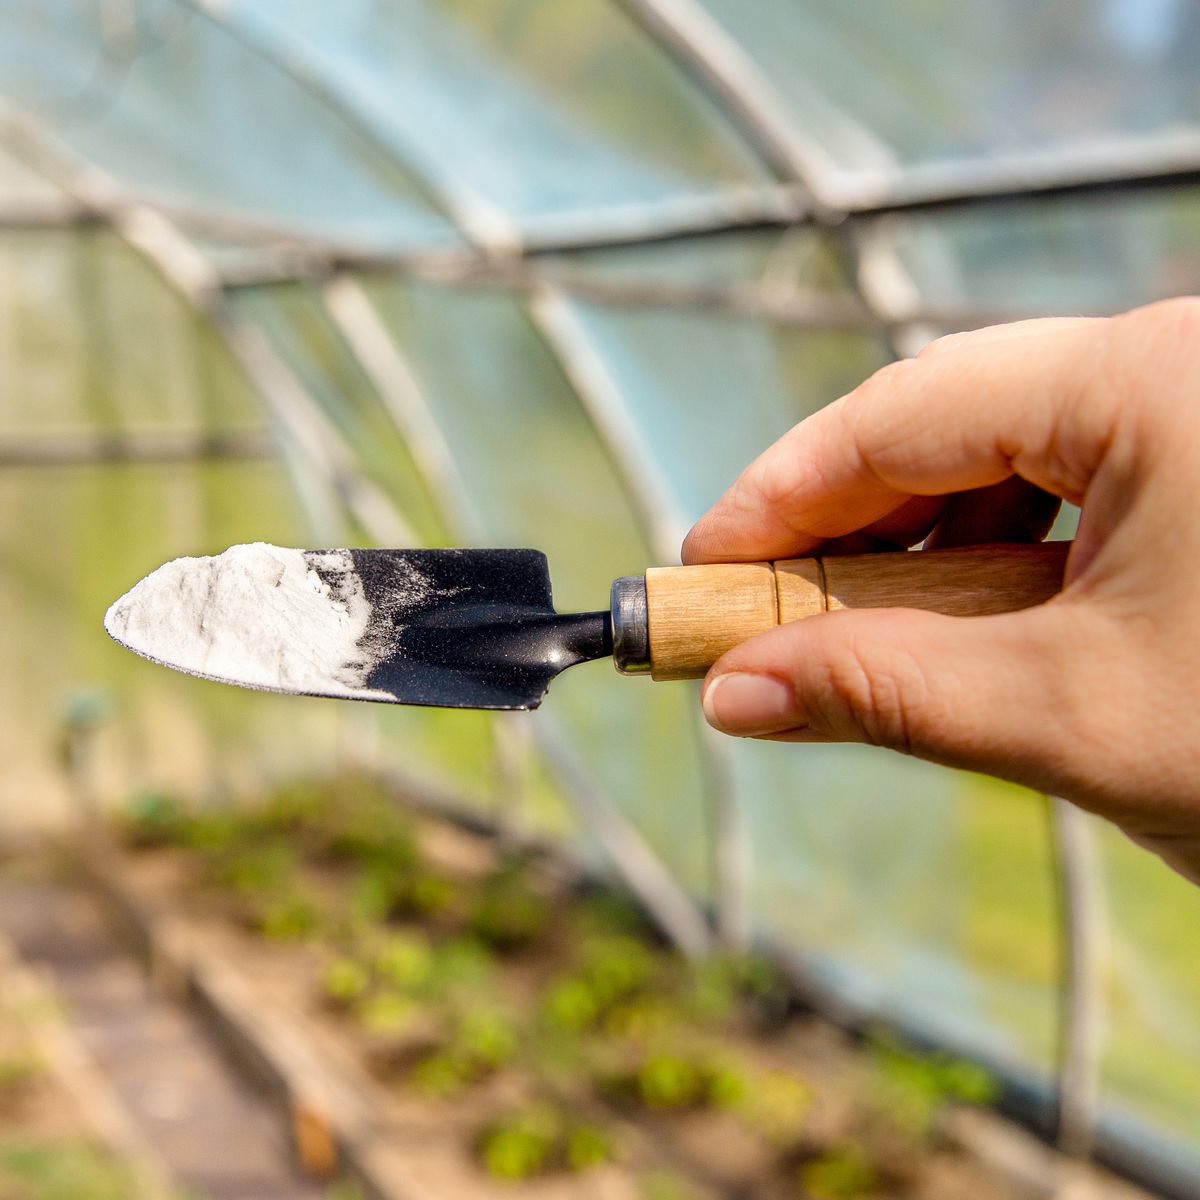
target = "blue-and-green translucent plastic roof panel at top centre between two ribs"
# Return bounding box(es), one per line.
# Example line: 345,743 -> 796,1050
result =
214,0 -> 766,242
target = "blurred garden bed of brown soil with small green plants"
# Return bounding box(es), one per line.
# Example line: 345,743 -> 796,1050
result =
97,780 -> 1123,1200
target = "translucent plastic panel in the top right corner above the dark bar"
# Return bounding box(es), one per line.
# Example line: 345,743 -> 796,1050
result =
686,0 -> 1200,204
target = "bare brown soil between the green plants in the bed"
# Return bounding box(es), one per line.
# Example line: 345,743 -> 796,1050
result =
103,796 -> 1030,1200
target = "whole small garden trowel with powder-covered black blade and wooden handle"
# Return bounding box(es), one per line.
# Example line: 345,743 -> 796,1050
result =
104,542 -> 1070,708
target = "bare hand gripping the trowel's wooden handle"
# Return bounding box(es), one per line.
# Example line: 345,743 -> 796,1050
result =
683,299 -> 1200,883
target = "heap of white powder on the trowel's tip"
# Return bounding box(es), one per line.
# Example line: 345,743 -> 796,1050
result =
104,542 -> 395,700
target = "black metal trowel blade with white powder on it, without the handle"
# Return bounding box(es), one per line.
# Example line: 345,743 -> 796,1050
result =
104,542 -> 612,709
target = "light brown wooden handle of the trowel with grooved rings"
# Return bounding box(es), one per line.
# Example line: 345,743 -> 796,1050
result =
646,541 -> 1070,679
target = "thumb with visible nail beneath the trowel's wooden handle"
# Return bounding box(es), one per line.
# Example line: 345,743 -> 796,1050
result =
703,601 -> 1094,786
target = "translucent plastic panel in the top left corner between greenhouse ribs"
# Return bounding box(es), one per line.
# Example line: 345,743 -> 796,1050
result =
0,0 -> 461,247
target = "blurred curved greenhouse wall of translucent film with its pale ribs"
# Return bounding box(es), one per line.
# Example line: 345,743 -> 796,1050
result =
0,0 -> 1200,1194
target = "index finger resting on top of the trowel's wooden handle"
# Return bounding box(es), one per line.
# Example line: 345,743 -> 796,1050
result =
683,318 -> 1115,563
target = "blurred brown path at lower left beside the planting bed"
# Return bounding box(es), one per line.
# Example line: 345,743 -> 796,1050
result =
0,875 -> 324,1200
